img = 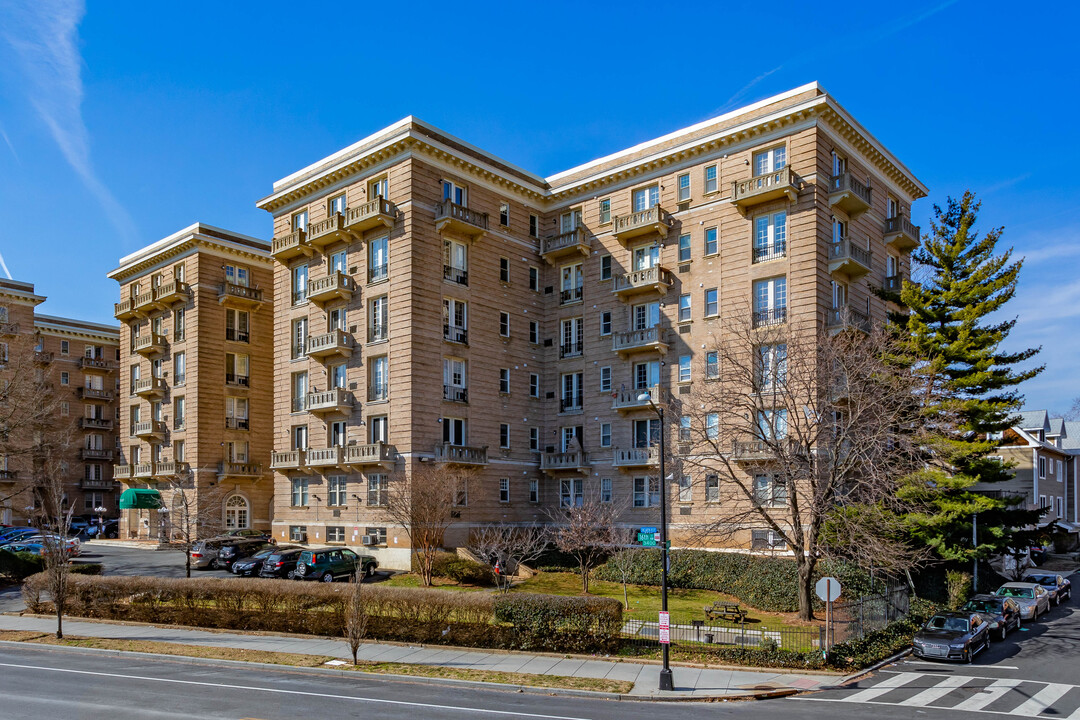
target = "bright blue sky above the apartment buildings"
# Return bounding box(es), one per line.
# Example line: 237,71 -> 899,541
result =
0,0 -> 1080,410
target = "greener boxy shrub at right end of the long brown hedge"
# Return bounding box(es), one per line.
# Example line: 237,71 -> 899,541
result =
495,593 -> 622,652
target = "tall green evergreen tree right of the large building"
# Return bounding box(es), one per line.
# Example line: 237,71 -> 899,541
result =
899,191 -> 1042,561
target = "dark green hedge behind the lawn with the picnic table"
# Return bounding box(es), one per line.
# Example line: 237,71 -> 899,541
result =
593,549 -> 870,612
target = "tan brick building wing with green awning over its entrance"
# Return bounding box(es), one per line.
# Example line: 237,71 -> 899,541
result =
109,223 -> 274,539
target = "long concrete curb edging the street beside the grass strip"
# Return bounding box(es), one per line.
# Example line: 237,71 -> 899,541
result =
0,640 -> 800,703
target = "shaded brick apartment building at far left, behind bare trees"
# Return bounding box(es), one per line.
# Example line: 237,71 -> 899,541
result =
0,280 -> 119,524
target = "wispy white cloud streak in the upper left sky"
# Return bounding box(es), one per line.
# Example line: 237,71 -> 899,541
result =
0,0 -> 136,240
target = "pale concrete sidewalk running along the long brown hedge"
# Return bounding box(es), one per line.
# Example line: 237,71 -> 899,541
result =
0,615 -> 840,699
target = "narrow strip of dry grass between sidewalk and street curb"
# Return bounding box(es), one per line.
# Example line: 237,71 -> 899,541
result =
0,630 -> 634,693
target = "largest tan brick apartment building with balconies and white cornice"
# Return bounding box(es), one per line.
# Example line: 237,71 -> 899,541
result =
258,84 -> 927,567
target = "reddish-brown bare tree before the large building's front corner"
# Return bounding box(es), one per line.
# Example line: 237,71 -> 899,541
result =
386,463 -> 473,586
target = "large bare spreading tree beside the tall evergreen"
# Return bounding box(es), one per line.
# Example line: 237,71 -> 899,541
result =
673,313 -> 918,620
